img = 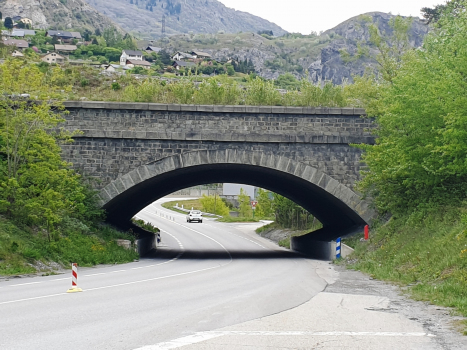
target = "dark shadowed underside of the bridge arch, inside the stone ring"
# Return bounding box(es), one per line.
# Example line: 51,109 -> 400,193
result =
104,163 -> 365,241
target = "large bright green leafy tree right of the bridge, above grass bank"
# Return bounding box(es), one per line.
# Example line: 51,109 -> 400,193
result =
359,2 -> 467,214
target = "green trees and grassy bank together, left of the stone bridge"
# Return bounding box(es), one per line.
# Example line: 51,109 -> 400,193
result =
0,60 -> 137,274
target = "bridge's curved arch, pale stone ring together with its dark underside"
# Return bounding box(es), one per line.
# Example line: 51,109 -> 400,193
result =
100,151 -> 373,241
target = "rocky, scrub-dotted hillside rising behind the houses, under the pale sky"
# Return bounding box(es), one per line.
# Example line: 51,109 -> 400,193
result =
156,12 -> 428,84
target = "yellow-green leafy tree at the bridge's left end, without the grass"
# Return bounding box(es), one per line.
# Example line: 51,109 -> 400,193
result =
0,60 -> 96,240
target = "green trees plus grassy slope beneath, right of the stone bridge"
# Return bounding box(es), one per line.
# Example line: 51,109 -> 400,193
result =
344,1 -> 467,334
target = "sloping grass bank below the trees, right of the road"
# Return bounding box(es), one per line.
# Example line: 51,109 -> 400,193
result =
346,208 -> 467,335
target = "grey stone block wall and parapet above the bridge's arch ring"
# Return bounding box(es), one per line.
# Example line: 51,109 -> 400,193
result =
58,102 -> 373,188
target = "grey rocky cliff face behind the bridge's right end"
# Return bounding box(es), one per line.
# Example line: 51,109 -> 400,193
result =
306,12 -> 429,84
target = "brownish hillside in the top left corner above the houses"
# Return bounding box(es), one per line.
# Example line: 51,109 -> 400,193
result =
0,0 -> 122,31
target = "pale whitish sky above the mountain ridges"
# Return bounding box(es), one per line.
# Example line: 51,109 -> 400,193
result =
219,0 -> 445,34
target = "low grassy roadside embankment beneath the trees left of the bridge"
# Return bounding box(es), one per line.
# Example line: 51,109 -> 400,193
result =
0,217 -> 138,276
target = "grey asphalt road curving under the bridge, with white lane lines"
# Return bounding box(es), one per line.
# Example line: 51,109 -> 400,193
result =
0,198 -> 326,350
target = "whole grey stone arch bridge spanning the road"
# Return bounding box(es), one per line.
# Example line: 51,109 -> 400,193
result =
62,101 -> 374,247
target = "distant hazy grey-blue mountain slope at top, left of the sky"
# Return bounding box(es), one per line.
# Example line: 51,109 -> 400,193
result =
86,0 -> 286,39
